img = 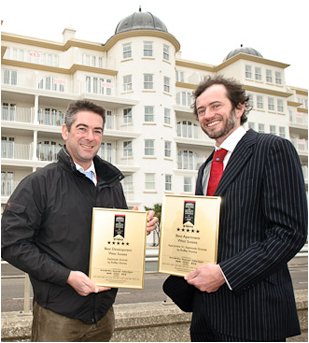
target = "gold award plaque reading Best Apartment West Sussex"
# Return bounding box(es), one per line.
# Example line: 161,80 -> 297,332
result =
158,195 -> 221,276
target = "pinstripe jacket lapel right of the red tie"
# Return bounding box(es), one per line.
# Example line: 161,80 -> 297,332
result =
215,130 -> 257,195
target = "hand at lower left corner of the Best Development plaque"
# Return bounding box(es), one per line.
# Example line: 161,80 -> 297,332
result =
67,271 -> 110,297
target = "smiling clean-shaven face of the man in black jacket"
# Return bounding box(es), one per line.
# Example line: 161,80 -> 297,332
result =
62,111 -> 103,170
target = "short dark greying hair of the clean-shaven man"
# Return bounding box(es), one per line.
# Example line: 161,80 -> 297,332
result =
64,100 -> 105,131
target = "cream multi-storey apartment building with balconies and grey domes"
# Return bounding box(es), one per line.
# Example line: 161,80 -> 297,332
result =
1,11 -> 308,220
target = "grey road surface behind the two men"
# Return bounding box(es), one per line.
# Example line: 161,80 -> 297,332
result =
1,256 -> 308,312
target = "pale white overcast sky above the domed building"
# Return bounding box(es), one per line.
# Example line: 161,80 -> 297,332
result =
0,0 -> 309,89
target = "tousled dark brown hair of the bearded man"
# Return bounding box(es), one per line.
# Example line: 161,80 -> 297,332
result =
191,75 -> 252,124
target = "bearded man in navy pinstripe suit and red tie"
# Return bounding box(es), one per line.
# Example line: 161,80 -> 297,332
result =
163,76 -> 307,342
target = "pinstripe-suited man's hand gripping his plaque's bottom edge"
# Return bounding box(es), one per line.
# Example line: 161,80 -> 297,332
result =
185,263 -> 225,293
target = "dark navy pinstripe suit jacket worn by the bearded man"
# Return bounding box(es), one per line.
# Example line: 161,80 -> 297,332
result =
164,130 -> 308,341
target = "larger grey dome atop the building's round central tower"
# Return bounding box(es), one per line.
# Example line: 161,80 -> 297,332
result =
115,8 -> 168,34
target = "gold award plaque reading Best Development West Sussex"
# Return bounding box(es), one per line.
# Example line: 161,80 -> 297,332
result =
89,208 -> 147,289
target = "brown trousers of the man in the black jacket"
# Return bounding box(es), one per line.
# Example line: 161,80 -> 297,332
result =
31,302 -> 115,342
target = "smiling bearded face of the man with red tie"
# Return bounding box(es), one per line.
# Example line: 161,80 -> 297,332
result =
196,84 -> 245,146
